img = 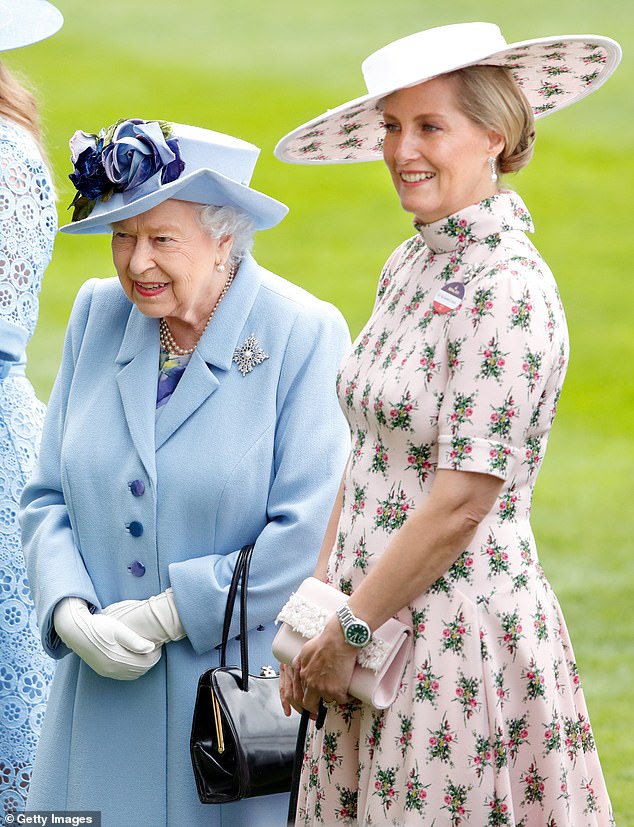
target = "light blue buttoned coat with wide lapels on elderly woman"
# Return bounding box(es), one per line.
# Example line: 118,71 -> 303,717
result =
21,257 -> 349,827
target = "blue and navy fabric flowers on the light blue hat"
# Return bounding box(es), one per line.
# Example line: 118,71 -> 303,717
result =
68,118 -> 185,221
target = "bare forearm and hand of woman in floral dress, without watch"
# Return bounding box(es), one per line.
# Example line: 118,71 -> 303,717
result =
292,470 -> 503,712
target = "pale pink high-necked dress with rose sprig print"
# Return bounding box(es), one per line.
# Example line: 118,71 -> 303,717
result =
297,191 -> 613,827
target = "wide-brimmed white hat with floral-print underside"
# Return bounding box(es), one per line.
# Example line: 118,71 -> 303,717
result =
275,23 -> 621,164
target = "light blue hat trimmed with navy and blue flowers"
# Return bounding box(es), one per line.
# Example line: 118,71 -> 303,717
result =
61,119 -> 288,234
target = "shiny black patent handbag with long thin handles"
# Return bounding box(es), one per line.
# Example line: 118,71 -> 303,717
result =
190,544 -> 300,804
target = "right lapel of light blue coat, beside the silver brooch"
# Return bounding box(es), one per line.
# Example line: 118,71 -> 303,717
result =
155,256 -> 261,450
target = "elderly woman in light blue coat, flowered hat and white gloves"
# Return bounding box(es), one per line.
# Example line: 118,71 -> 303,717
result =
21,120 -> 349,827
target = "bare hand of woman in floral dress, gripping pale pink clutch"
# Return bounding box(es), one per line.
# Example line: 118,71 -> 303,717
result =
292,617 -> 358,715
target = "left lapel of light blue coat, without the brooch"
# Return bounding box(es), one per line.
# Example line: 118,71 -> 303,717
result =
116,307 -> 159,480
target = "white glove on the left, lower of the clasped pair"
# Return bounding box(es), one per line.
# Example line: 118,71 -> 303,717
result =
53,597 -> 161,681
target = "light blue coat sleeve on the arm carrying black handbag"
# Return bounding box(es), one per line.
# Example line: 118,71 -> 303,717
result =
169,302 -> 350,654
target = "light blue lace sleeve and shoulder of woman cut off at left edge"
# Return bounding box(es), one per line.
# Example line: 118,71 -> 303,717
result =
0,119 -> 57,362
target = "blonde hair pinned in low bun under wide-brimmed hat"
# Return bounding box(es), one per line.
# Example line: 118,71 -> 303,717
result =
448,66 -> 535,172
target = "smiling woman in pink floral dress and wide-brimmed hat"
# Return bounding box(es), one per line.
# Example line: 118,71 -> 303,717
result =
277,23 -> 620,827
